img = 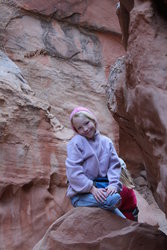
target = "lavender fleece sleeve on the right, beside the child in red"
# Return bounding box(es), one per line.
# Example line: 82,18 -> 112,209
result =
107,141 -> 122,192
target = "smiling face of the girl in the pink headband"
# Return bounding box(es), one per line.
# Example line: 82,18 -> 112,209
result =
73,115 -> 96,139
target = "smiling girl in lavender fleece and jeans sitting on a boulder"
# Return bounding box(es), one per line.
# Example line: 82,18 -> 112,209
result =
66,107 -> 125,218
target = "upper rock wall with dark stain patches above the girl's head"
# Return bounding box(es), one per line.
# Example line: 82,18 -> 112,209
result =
0,0 -> 124,146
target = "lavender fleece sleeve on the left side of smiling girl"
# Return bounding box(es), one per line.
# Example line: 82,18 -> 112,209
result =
66,141 -> 93,193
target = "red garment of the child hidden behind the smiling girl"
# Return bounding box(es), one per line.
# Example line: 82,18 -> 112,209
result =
119,186 -> 137,220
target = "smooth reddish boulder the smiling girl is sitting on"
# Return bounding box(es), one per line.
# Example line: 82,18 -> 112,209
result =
33,208 -> 167,250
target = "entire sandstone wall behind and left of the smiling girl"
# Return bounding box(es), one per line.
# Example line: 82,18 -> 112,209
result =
0,0 -> 124,250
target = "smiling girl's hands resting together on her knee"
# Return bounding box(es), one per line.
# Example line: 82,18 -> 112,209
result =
90,185 -> 117,202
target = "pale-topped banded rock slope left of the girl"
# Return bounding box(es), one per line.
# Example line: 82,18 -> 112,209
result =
0,52 -> 71,250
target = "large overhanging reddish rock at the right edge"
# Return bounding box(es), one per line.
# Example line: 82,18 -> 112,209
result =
108,1 -> 167,214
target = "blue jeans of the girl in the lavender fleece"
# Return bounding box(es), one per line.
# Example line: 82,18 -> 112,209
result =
71,193 -> 126,218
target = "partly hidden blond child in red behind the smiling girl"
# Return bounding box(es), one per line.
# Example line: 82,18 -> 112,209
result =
119,158 -> 139,221
